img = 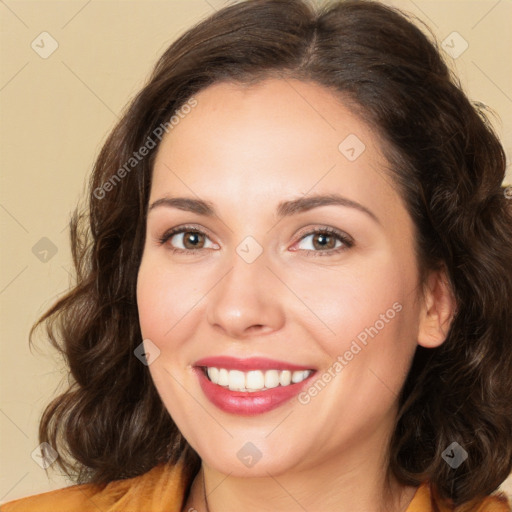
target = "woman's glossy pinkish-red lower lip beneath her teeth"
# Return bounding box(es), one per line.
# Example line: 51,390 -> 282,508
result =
195,368 -> 315,416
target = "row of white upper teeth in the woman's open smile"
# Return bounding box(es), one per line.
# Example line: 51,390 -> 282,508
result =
207,367 -> 313,391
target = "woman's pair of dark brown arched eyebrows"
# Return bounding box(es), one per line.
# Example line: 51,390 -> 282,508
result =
148,194 -> 380,224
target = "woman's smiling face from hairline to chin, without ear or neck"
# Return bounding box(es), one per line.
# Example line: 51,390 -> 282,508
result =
137,79 -> 428,476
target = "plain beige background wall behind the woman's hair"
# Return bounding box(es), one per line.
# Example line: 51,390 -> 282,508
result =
0,0 -> 512,502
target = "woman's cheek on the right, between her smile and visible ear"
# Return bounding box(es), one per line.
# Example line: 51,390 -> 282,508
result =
296,252 -> 418,400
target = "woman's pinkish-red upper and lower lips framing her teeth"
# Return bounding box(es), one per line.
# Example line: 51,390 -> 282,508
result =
194,356 -> 316,416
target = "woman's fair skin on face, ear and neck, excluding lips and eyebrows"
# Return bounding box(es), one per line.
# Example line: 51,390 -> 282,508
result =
137,79 -> 454,512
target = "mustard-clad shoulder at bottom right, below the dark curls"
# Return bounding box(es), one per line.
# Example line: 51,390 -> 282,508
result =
406,482 -> 512,512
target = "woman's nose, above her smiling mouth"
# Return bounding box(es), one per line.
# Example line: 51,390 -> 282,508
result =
206,252 -> 285,339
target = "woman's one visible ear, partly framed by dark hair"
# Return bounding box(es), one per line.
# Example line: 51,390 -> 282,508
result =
418,270 -> 456,348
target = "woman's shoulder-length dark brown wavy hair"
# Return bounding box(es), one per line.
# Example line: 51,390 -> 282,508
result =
30,0 -> 512,506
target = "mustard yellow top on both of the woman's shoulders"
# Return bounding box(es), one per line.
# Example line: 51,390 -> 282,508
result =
0,463 -> 512,512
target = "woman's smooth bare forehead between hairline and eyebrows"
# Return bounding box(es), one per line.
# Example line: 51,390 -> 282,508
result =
150,79 -> 404,222
